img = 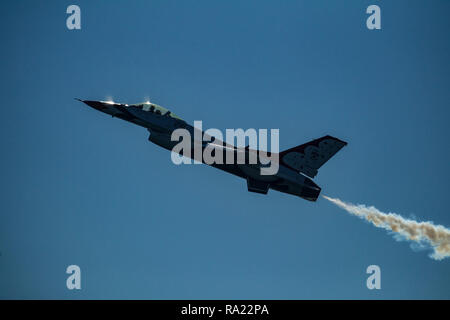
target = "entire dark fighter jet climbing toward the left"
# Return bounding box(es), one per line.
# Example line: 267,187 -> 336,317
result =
77,99 -> 347,201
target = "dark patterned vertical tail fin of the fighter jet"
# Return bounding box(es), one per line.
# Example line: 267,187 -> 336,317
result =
280,136 -> 347,178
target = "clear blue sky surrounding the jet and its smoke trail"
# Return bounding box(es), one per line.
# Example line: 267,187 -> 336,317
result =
0,0 -> 450,299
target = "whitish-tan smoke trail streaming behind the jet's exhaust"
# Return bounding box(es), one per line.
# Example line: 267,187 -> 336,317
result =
322,196 -> 450,260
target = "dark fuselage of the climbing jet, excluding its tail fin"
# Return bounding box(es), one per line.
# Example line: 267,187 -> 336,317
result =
80,100 -> 321,201
